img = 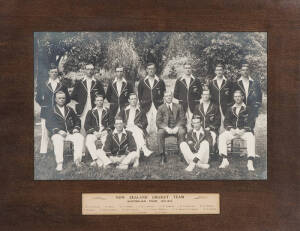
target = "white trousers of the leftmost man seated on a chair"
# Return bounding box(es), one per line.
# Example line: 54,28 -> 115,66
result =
51,133 -> 84,164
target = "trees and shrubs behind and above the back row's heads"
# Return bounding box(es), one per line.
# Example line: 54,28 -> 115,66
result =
35,32 -> 267,93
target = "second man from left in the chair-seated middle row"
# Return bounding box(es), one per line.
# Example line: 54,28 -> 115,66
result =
84,94 -> 113,167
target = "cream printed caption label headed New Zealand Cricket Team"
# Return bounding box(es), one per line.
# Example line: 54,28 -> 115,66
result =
82,193 -> 220,215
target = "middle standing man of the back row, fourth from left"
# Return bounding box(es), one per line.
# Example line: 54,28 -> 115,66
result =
138,63 -> 166,133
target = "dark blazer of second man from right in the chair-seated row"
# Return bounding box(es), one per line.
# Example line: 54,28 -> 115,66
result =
194,102 -> 221,133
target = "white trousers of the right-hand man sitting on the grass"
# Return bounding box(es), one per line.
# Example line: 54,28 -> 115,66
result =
180,140 -> 209,164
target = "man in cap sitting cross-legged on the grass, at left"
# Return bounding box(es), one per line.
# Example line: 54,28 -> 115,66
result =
98,115 -> 140,169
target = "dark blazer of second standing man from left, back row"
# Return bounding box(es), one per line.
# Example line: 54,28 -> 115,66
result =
71,79 -> 105,115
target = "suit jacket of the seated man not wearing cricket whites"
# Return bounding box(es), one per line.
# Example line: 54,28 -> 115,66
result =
156,103 -> 187,129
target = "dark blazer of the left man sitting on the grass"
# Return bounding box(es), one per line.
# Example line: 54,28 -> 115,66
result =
103,130 -> 137,156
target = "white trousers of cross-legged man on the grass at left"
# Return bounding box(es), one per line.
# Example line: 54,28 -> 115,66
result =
97,149 -> 139,165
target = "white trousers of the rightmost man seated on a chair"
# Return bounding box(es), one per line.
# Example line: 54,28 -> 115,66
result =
219,131 -> 255,157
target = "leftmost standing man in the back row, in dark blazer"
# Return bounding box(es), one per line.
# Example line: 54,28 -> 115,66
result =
35,63 -> 70,153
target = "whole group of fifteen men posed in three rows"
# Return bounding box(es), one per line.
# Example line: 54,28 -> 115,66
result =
36,62 -> 262,172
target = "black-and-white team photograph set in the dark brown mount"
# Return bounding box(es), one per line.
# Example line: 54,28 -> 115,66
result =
33,32 -> 268,180
